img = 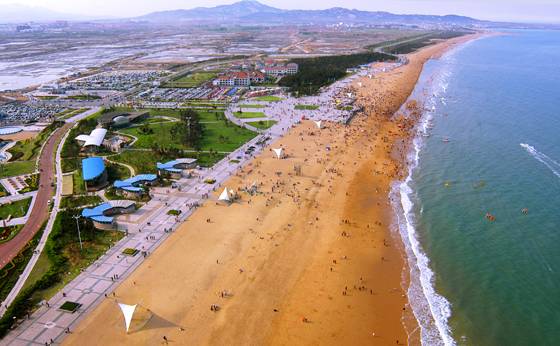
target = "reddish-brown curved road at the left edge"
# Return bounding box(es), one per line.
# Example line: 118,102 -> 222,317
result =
0,123 -> 73,268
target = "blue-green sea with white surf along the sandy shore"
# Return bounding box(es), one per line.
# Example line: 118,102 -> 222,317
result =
393,31 -> 560,346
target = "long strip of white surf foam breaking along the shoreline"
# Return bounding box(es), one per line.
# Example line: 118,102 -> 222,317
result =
391,56 -> 456,346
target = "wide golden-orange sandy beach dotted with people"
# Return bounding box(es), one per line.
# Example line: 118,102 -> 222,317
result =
64,36 -> 480,345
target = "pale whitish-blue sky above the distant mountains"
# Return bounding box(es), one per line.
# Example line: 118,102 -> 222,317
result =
0,0 -> 560,23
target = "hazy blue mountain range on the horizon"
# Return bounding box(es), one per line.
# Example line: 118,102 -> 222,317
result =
136,0 -> 482,26
